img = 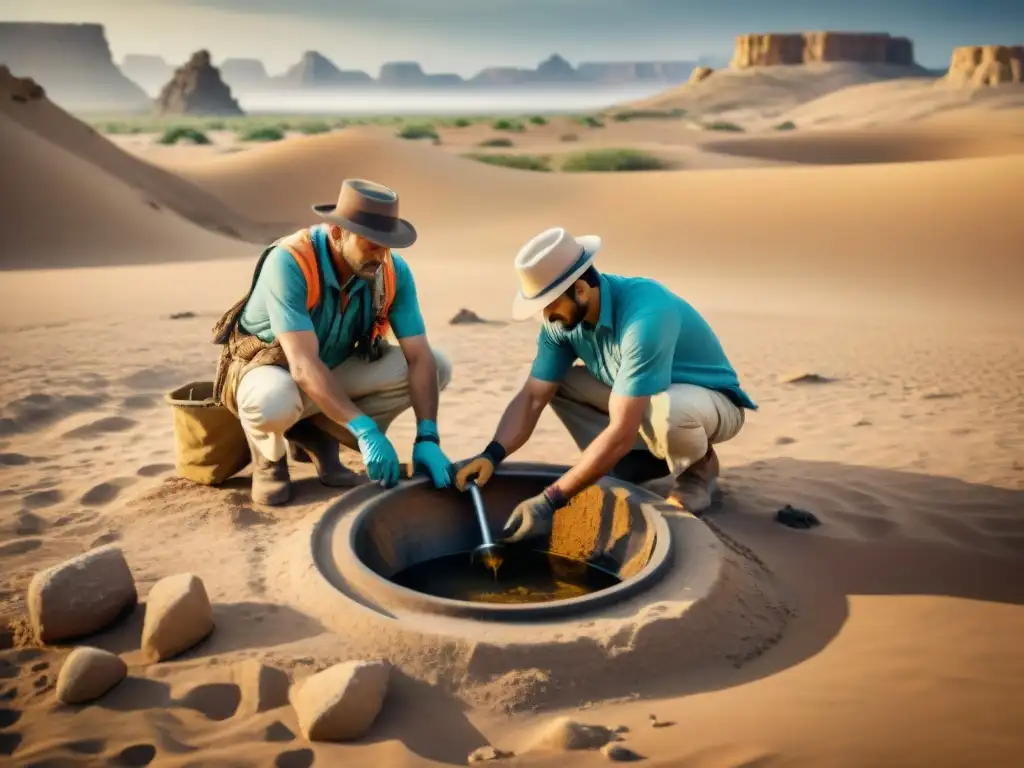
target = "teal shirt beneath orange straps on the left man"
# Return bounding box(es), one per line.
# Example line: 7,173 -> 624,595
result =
240,225 -> 426,369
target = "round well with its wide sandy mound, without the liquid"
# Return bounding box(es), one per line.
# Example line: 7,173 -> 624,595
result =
292,462 -> 791,712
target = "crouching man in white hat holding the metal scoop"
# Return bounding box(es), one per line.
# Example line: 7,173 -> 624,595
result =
456,227 -> 757,542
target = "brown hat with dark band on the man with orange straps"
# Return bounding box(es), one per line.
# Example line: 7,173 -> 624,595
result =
312,178 -> 417,248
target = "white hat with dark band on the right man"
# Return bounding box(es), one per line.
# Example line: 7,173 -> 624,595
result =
512,226 -> 601,321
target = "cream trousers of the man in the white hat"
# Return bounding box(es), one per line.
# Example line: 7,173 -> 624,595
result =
551,365 -> 744,477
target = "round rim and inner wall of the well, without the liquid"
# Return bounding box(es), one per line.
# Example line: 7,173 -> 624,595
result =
342,462 -> 672,621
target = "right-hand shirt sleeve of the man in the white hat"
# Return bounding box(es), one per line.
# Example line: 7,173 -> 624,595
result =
611,312 -> 679,397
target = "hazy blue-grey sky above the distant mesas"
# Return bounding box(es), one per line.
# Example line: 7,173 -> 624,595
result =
0,0 -> 1024,75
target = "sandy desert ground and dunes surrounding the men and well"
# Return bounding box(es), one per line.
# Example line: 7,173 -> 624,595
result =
0,67 -> 1024,766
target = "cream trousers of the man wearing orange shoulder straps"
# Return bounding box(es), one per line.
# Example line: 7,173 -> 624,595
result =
236,345 -> 452,461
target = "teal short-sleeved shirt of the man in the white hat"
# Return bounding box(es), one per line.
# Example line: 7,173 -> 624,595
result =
530,273 -> 758,411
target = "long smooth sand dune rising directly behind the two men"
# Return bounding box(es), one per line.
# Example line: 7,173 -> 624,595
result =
153,130 -> 1024,315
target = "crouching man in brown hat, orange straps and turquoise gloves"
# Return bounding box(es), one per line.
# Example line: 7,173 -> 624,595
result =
214,179 -> 452,505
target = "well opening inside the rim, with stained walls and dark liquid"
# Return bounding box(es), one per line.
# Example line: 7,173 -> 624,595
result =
350,465 -> 668,612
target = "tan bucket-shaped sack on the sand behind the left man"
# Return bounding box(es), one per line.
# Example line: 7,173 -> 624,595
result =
166,381 -> 252,485
